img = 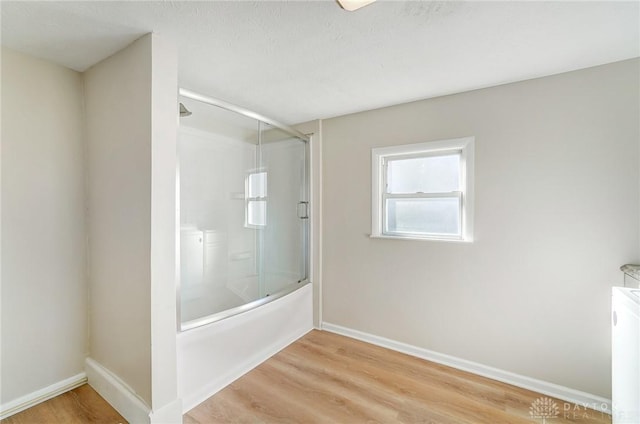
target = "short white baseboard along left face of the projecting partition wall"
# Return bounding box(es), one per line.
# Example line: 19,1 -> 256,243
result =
85,358 -> 151,423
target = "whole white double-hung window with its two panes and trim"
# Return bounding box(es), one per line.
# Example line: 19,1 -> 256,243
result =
371,137 -> 473,241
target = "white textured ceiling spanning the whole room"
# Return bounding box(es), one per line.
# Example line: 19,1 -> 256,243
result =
0,0 -> 640,124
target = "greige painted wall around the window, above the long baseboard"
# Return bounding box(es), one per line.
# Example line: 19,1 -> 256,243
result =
322,59 -> 640,397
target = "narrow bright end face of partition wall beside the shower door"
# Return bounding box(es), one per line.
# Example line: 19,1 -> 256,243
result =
146,34 -> 182,423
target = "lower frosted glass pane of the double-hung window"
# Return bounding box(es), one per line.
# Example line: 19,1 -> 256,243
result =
386,197 -> 460,235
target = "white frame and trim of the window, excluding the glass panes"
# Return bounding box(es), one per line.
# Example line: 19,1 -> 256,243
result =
371,137 -> 475,242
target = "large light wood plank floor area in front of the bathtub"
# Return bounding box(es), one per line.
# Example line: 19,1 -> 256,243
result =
184,331 -> 611,424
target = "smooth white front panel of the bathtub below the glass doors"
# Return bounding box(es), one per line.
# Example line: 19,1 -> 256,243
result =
178,284 -> 313,412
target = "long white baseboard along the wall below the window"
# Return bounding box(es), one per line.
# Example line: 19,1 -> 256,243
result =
322,322 -> 611,415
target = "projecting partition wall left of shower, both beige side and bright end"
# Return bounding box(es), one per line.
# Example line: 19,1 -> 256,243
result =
85,34 -> 180,419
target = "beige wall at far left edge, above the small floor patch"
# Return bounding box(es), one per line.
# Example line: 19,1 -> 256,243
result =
0,47 -> 87,405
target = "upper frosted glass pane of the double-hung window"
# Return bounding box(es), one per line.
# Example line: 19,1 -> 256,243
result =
387,153 -> 460,193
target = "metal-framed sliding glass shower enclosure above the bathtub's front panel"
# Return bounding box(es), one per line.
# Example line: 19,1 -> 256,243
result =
177,90 -> 309,331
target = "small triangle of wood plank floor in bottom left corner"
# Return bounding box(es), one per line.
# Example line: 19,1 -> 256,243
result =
0,384 -> 126,424
